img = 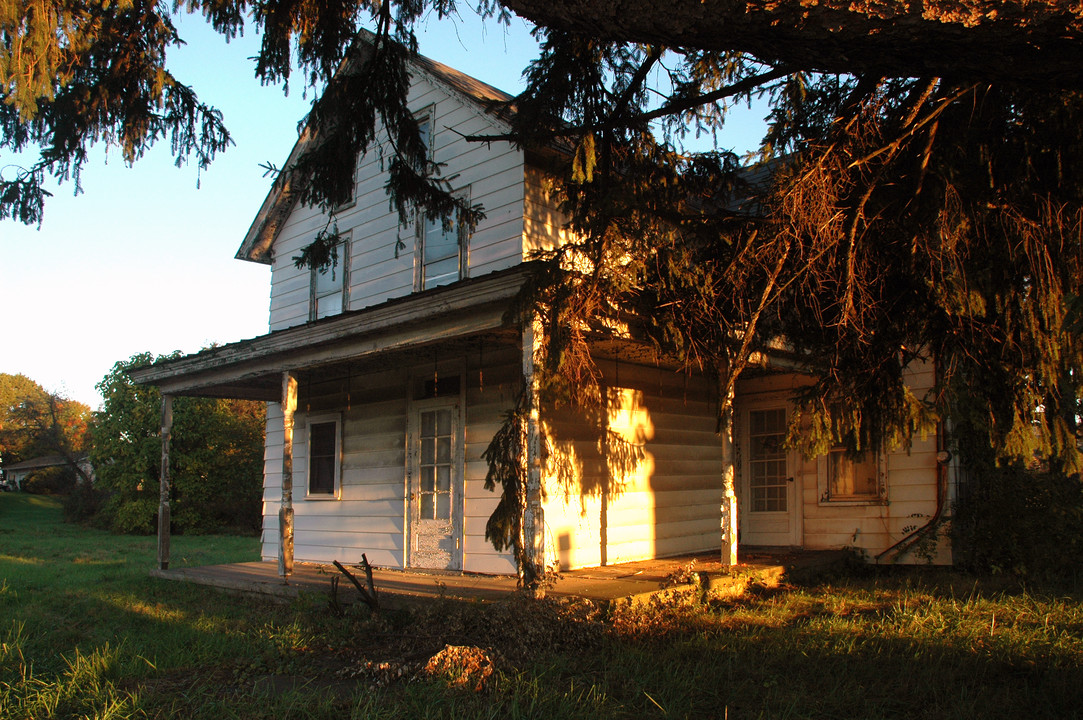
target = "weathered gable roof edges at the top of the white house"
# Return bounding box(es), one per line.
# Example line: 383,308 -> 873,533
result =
235,40 -> 514,264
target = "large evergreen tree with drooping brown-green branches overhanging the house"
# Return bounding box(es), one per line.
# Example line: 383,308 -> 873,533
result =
0,0 -> 1083,470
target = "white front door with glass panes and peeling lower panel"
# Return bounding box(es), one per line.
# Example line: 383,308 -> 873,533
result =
407,400 -> 462,570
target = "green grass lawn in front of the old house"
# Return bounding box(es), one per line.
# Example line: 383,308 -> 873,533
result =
0,493 -> 1083,720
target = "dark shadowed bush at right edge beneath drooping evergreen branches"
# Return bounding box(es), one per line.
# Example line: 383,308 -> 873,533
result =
952,466 -> 1083,579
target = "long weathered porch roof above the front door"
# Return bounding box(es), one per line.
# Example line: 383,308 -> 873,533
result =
129,263 -> 530,401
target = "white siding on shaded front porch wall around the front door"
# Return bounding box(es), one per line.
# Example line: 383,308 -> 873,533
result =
262,345 -> 520,574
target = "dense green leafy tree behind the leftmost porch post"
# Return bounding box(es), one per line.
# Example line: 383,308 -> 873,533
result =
91,353 -> 265,533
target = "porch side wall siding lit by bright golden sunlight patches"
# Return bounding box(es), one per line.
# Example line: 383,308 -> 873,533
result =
544,362 -> 721,568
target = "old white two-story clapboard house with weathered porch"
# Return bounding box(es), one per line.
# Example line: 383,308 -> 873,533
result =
132,47 -> 950,574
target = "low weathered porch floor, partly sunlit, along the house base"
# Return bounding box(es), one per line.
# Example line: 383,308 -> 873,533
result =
151,548 -> 850,606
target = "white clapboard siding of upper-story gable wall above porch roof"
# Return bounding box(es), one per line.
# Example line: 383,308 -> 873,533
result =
270,73 -> 525,330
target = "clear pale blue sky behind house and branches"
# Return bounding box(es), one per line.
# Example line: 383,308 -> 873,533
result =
0,11 -> 761,408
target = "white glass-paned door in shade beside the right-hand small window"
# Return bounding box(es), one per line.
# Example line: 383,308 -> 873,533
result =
738,406 -> 800,546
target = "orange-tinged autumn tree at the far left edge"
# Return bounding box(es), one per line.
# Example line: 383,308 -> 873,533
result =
0,374 -> 90,482
